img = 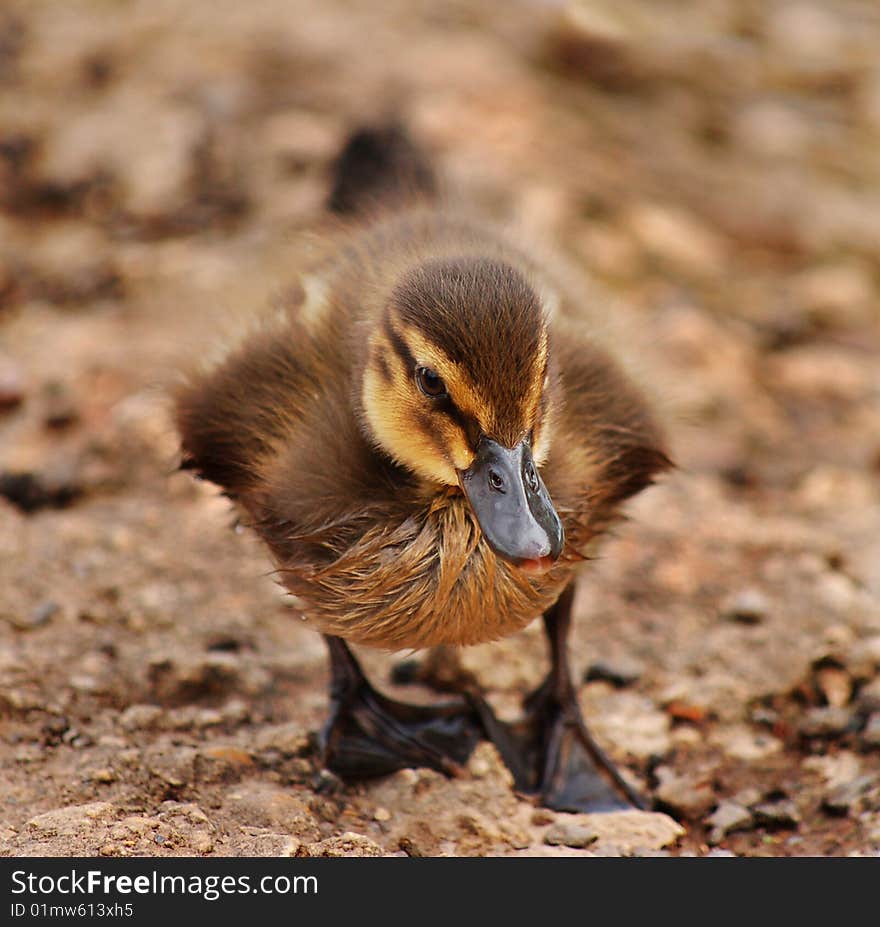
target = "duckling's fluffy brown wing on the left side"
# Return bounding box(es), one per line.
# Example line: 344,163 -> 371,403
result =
175,312 -> 411,556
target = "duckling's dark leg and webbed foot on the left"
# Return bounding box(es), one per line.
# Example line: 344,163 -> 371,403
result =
321,636 -> 483,779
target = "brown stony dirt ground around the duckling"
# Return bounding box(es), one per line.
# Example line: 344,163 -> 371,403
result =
0,0 -> 880,856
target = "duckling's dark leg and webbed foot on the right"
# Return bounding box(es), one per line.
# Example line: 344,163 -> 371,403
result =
483,584 -> 648,811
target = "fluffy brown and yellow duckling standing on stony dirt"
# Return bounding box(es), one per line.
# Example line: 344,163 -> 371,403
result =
175,126 -> 670,811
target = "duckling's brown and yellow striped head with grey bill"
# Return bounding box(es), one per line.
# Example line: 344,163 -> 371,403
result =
361,257 -> 563,571
